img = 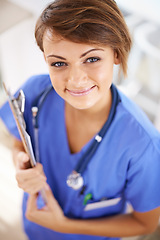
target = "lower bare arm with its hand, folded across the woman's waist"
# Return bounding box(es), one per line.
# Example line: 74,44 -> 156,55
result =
26,185 -> 160,237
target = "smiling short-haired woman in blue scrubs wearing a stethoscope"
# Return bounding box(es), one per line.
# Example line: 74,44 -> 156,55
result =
0,0 -> 160,240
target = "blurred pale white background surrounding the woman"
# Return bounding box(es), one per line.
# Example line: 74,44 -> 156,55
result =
0,0 -> 160,240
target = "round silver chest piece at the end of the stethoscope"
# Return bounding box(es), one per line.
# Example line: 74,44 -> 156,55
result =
67,171 -> 83,190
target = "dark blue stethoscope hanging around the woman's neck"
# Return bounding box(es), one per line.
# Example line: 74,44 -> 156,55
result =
32,84 -> 120,190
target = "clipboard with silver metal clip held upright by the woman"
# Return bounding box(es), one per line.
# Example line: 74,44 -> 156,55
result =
3,82 -> 36,167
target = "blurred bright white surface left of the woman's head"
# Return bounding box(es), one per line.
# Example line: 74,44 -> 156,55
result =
0,17 -> 48,91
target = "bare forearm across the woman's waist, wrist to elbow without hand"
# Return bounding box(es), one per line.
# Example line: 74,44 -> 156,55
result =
62,214 -> 155,237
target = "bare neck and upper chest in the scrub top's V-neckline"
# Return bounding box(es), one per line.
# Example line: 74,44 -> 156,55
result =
65,87 -> 112,153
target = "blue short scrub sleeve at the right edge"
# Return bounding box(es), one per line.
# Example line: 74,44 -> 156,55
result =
125,140 -> 160,212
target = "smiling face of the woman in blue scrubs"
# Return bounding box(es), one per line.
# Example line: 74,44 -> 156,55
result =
43,32 -> 119,109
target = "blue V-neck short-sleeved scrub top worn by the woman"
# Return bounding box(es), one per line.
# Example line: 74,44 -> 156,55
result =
0,75 -> 160,240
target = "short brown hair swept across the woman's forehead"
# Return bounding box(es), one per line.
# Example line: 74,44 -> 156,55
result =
35,0 -> 131,75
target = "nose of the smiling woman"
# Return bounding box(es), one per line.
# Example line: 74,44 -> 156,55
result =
67,66 -> 87,87
